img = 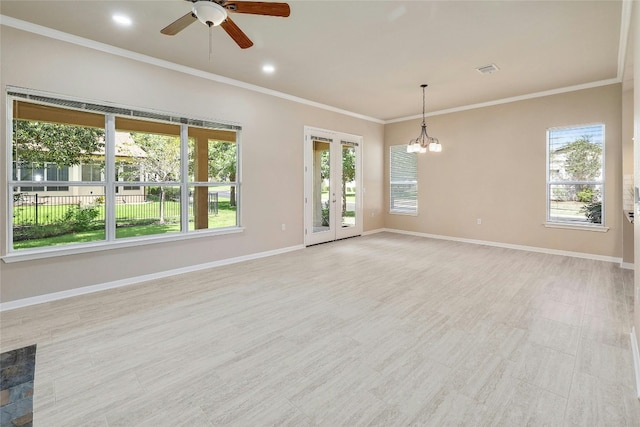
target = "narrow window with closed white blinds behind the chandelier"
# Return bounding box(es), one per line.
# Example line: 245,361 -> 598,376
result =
389,144 -> 418,215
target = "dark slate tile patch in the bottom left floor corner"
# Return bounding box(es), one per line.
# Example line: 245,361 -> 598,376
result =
0,344 -> 36,427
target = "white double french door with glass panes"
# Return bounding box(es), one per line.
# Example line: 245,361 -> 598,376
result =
304,126 -> 362,246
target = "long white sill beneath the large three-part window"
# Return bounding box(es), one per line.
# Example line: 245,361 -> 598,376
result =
0,227 -> 244,264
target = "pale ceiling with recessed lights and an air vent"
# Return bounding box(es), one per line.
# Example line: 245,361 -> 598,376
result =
0,0 -> 629,120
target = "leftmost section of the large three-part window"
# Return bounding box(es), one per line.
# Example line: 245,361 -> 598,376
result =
9,107 -> 106,249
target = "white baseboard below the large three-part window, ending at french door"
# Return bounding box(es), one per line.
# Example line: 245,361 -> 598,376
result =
0,245 -> 304,311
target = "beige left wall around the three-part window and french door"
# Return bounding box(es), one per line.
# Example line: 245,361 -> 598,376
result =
0,27 -> 384,303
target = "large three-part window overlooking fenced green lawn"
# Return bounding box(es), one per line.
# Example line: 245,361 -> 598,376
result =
8,89 -> 240,251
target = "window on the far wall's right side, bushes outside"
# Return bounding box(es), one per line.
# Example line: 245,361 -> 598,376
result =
547,124 -> 605,226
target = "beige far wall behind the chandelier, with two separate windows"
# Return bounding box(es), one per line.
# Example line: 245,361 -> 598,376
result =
384,84 -> 622,258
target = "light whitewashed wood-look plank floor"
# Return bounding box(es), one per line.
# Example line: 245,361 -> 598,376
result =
0,233 -> 640,427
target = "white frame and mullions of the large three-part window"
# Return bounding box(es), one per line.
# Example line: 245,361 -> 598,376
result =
0,86 -> 244,262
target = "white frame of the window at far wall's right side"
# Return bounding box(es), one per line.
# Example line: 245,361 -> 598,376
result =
544,123 -> 609,232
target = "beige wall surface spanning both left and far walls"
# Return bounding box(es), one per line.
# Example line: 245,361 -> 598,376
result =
0,23 -> 624,302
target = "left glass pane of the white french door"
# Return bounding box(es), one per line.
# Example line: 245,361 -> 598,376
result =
311,141 -> 331,233
